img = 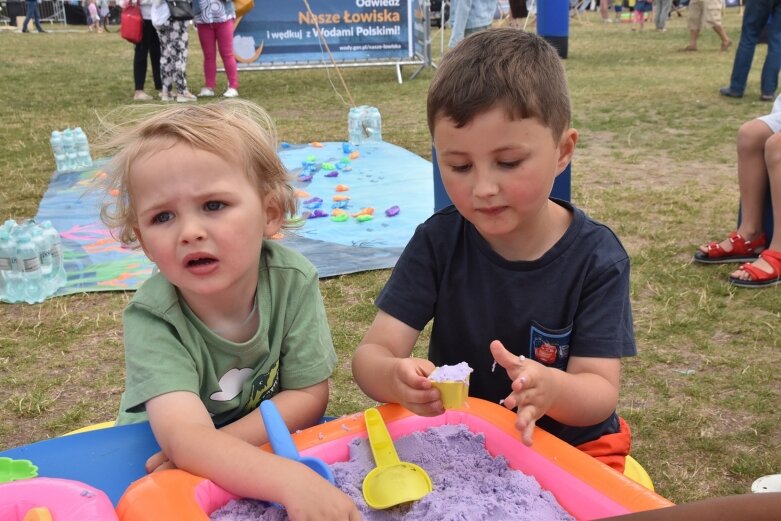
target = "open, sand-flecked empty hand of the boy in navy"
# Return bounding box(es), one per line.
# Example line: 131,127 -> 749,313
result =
491,340 -> 558,446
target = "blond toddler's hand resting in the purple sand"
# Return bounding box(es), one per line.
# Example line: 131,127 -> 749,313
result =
282,471 -> 361,521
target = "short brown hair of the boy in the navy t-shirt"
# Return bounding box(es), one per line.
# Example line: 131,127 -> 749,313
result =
426,28 -> 570,140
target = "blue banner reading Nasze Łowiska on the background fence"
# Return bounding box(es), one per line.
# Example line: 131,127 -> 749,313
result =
233,0 -> 414,67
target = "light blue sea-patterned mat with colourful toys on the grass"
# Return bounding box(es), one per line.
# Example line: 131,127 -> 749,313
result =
35,143 -> 434,295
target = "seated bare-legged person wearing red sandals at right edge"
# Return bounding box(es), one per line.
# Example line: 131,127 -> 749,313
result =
694,96 -> 781,288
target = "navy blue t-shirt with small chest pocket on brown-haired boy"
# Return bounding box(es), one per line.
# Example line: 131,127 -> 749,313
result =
376,200 -> 636,445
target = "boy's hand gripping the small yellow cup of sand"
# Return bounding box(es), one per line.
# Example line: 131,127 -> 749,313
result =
392,358 -> 445,416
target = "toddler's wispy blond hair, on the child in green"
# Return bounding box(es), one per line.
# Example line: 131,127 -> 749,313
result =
95,100 -> 297,246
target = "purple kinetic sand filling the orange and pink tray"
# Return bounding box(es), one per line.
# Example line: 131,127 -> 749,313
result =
211,425 -> 574,521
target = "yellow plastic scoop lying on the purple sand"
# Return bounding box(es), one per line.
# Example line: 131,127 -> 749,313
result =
363,408 -> 432,510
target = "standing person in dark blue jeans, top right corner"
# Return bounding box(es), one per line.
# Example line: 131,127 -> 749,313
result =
719,0 -> 781,101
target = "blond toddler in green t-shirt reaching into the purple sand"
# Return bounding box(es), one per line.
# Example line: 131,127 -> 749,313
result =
102,101 -> 359,520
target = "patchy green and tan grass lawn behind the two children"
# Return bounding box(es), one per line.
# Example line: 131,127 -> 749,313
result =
0,9 -> 781,502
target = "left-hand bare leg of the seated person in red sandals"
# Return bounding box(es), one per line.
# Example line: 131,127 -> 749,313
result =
700,119 -> 781,253
